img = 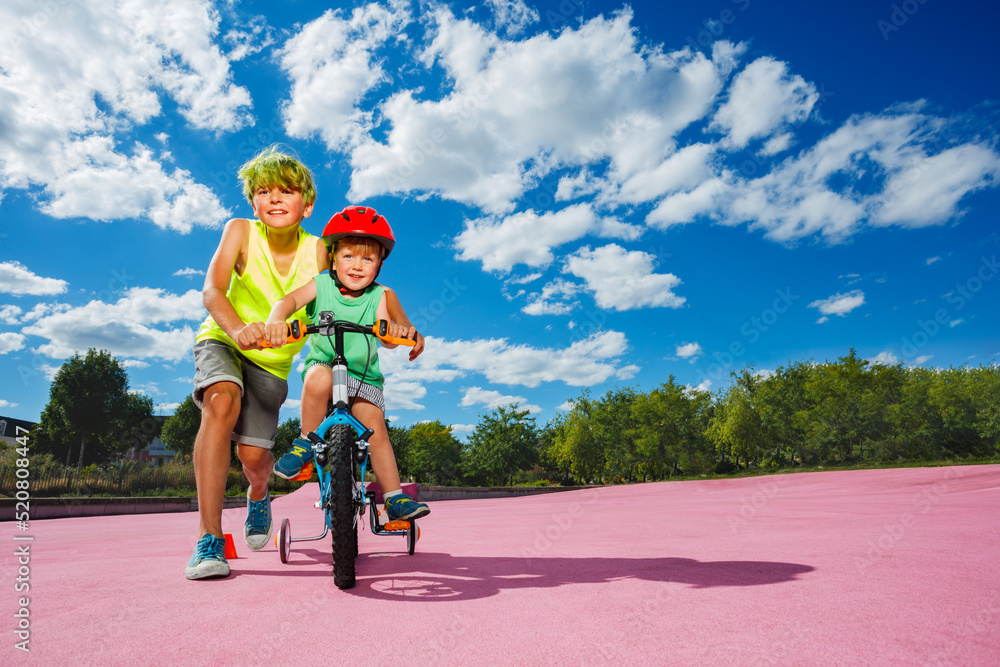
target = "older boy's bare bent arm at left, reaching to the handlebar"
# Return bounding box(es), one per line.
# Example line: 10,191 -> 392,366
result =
201,218 -> 264,350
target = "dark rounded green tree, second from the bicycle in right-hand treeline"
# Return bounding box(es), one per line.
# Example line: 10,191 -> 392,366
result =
463,405 -> 538,485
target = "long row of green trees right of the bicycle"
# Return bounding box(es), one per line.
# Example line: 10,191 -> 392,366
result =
390,350 -> 1000,485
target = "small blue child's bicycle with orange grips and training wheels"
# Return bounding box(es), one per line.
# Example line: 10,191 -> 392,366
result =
266,311 -> 420,589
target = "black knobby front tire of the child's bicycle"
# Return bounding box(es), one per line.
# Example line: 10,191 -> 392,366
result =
326,424 -> 358,589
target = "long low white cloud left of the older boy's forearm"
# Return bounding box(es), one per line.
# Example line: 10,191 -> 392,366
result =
22,287 -> 205,361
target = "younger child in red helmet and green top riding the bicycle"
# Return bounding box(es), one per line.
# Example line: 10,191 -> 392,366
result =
266,206 -> 430,521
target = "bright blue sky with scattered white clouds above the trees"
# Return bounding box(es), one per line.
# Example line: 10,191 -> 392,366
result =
0,0 -> 1000,436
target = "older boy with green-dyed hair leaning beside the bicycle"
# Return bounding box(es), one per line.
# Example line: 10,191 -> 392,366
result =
184,147 -> 328,579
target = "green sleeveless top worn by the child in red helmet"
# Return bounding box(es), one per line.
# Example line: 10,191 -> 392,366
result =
303,273 -> 385,389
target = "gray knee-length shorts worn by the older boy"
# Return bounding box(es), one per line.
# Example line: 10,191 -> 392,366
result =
193,340 -> 288,449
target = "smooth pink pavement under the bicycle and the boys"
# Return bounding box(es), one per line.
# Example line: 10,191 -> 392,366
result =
7,465 -> 1000,666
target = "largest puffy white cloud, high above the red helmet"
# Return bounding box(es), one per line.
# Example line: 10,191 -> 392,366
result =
350,9 -> 722,213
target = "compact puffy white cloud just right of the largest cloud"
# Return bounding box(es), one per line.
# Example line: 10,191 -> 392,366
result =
710,57 -> 819,148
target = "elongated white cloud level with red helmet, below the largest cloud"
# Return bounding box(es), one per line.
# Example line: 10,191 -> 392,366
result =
455,204 -> 597,272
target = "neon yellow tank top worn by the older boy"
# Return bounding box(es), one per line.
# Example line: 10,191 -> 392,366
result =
195,220 -> 325,379
